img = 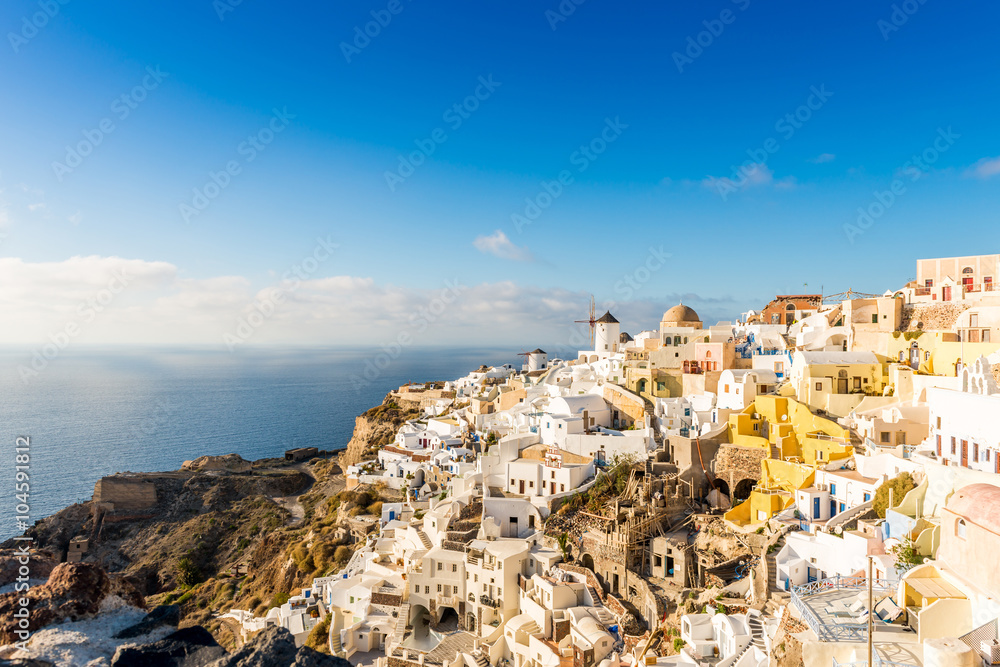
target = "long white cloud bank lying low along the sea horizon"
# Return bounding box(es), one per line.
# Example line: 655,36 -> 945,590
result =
0,256 -> 745,350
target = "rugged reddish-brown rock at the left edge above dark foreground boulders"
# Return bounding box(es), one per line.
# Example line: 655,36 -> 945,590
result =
0,563 -> 111,644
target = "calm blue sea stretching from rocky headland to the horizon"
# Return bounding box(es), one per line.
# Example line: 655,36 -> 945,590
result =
0,348 -> 516,539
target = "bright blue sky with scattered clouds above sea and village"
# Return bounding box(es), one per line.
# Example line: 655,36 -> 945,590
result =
0,0 -> 1000,345
